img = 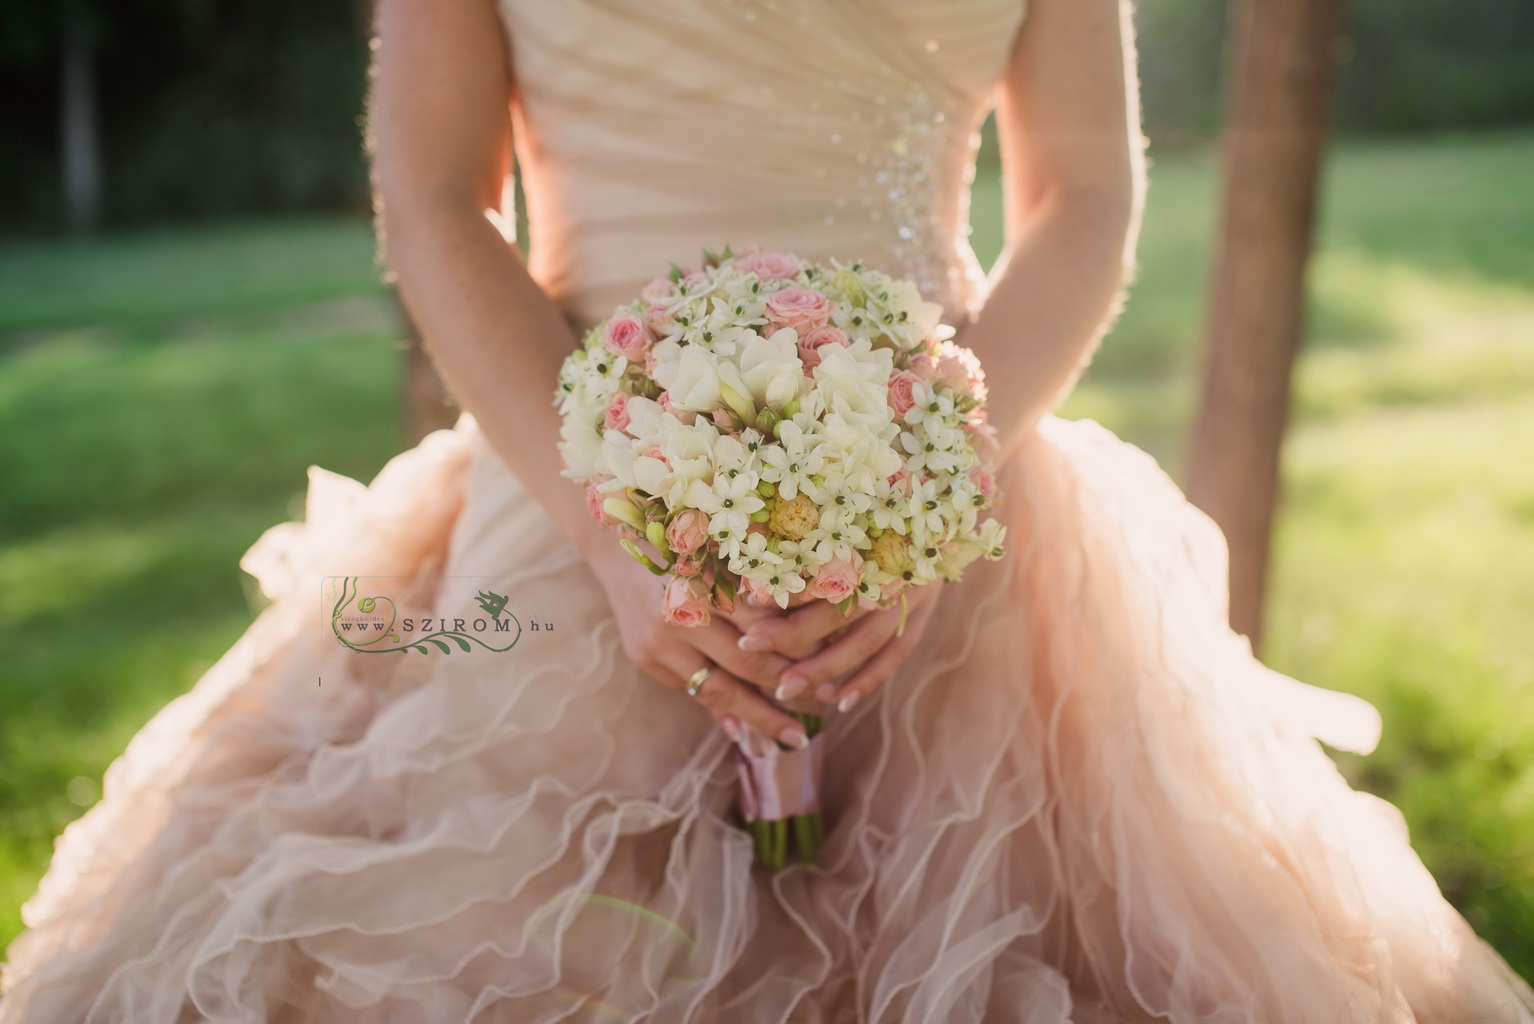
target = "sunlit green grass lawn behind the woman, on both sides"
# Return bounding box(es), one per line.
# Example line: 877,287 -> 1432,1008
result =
0,135 -> 1534,975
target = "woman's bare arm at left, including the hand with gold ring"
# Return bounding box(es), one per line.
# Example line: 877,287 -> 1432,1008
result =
370,0 -> 802,743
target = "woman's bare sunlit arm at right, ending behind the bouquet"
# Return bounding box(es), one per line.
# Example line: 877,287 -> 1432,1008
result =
959,0 -> 1144,451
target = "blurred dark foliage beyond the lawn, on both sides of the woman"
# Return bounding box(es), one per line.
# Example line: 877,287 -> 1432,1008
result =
0,0 -> 1534,231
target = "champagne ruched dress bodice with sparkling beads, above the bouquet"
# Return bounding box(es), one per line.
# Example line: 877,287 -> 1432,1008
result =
499,0 -> 1025,325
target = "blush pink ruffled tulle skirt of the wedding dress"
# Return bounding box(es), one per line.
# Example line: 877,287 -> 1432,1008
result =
0,417 -> 1534,1024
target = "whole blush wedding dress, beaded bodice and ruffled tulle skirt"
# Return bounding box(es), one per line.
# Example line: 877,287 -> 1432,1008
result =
0,0 -> 1534,1024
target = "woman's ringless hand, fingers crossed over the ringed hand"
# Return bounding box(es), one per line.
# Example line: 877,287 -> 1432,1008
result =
741,584 -> 942,711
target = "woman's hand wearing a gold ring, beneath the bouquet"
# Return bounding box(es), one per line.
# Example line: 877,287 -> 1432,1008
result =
589,544 -> 808,748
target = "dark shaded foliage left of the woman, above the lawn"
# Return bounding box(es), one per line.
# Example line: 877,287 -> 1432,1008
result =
0,0 -> 367,230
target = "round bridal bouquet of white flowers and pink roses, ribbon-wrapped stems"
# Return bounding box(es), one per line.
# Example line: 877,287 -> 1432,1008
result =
557,250 -> 1005,865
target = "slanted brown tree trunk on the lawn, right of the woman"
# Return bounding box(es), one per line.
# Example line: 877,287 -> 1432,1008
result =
1187,0 -> 1344,647
